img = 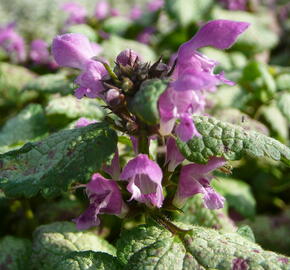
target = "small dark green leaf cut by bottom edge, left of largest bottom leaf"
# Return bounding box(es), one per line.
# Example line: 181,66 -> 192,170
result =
54,251 -> 121,270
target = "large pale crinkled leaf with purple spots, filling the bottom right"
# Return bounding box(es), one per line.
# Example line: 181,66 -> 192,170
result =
117,225 -> 290,270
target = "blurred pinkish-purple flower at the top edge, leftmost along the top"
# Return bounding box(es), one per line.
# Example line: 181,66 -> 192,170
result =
61,2 -> 87,25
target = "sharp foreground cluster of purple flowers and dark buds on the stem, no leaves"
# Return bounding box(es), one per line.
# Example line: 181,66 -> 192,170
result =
52,20 -> 249,229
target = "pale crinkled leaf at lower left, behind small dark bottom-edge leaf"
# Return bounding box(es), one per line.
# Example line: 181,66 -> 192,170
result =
31,222 -> 115,270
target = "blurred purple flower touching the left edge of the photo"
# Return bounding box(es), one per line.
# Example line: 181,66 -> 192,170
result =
0,23 -> 26,62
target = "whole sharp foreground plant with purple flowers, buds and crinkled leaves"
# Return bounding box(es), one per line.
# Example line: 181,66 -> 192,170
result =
0,17 -> 290,270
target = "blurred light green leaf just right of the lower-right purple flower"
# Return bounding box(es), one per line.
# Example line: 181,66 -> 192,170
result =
213,176 -> 256,218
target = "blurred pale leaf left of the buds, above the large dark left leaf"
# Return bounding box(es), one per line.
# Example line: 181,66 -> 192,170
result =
45,96 -> 104,121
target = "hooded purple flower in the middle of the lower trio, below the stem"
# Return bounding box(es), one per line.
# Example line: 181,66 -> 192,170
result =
120,154 -> 164,208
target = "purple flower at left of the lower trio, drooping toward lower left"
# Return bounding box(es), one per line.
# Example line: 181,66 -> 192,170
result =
73,173 -> 127,230
